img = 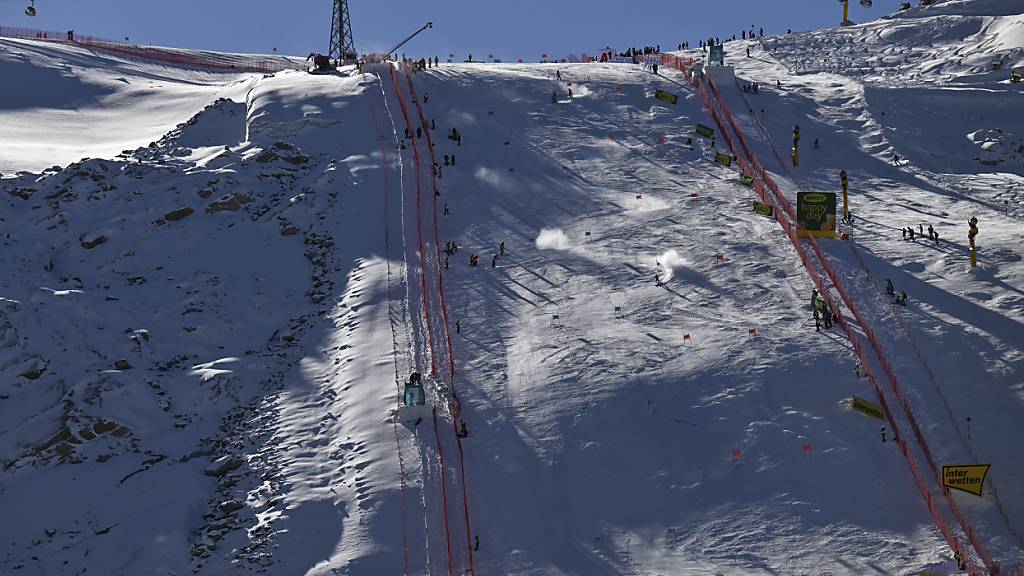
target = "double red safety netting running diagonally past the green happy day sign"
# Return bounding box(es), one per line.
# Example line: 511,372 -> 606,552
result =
663,53 -> 998,576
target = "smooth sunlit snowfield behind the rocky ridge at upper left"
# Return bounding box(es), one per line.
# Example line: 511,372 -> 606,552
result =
0,39 -> 255,174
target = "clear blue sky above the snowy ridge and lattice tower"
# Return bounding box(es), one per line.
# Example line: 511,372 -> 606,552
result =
0,0 -> 899,61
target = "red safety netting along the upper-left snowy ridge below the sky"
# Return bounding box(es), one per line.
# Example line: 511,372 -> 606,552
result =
0,27 -> 304,74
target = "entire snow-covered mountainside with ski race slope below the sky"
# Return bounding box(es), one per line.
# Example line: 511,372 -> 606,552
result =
0,0 -> 1024,576
